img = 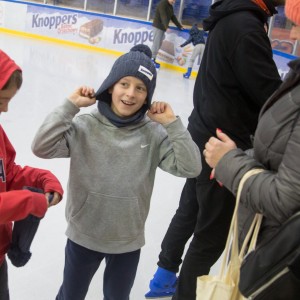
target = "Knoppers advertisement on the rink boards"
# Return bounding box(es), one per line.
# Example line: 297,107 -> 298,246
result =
0,0 -> 292,72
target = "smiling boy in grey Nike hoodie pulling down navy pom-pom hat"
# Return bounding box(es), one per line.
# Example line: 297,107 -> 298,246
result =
32,45 -> 201,300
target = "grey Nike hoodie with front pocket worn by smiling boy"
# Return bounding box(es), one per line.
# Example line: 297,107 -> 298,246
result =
32,100 -> 201,254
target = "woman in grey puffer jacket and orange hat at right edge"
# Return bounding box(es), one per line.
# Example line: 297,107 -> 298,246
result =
204,0 -> 300,299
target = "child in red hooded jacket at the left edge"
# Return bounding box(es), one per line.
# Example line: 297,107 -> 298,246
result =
0,50 -> 63,300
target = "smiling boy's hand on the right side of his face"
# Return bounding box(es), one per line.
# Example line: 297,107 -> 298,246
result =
147,101 -> 176,124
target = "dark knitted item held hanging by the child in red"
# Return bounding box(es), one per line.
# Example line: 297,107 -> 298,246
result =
7,186 -> 53,267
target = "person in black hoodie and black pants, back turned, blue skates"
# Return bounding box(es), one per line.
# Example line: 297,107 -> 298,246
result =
146,0 -> 285,300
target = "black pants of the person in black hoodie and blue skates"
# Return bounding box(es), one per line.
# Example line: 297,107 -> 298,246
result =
158,157 -> 235,300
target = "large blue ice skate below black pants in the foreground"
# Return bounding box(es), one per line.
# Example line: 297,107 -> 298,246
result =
145,267 -> 177,299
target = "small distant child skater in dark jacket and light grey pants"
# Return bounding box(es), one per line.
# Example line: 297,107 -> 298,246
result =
180,24 -> 205,79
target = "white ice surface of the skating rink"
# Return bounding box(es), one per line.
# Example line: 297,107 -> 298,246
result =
0,33 -> 218,300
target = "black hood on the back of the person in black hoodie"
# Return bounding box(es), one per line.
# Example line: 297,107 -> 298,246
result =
203,0 -> 277,31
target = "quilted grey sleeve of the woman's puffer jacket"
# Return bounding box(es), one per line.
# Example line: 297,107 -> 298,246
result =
215,135 -> 300,223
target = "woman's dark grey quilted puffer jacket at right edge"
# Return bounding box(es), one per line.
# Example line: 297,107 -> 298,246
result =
215,59 -> 300,246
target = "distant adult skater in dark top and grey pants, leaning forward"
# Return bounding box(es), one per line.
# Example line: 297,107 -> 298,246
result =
151,0 -> 184,68
